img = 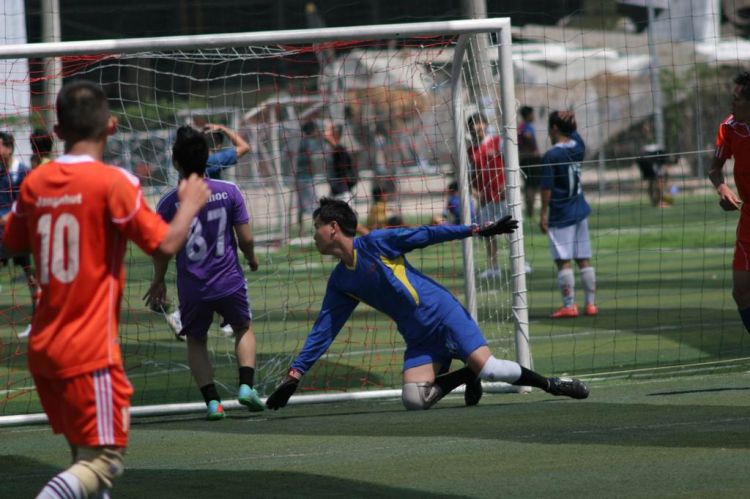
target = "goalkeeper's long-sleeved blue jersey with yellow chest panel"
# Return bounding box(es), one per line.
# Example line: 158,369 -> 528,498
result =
292,225 -> 471,373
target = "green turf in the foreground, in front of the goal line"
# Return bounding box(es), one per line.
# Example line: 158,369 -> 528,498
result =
0,373 -> 750,499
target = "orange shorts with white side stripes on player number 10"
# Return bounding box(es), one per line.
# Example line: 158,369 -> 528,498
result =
34,366 -> 133,447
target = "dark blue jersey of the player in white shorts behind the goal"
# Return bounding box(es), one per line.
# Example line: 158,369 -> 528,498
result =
542,132 -> 591,227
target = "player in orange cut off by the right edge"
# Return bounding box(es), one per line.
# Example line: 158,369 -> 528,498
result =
708,72 -> 750,332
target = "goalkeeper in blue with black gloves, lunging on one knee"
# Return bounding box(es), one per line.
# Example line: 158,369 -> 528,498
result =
266,198 -> 589,410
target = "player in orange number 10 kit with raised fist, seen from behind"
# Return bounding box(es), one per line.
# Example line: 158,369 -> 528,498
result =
3,81 -> 210,499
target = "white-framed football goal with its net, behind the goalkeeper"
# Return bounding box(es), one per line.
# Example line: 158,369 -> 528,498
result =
0,20 -> 528,422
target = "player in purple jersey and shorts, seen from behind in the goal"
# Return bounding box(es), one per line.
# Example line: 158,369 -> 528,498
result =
144,126 -> 264,420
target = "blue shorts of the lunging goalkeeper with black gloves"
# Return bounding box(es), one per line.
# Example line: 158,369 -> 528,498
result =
404,305 -> 487,371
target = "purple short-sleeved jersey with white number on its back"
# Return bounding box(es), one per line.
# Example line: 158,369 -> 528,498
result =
156,179 -> 249,302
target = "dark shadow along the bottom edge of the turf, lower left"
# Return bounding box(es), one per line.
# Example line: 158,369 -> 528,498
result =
0,456 -> 470,499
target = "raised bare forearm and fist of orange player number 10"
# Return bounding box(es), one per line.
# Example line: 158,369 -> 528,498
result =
154,174 -> 211,257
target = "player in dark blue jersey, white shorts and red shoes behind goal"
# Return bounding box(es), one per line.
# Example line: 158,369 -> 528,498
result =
539,111 -> 598,319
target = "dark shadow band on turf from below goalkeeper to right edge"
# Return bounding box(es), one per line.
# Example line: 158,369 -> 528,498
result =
167,393 -> 750,449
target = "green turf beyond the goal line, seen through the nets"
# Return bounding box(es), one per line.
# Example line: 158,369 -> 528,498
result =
0,196 -> 750,415
